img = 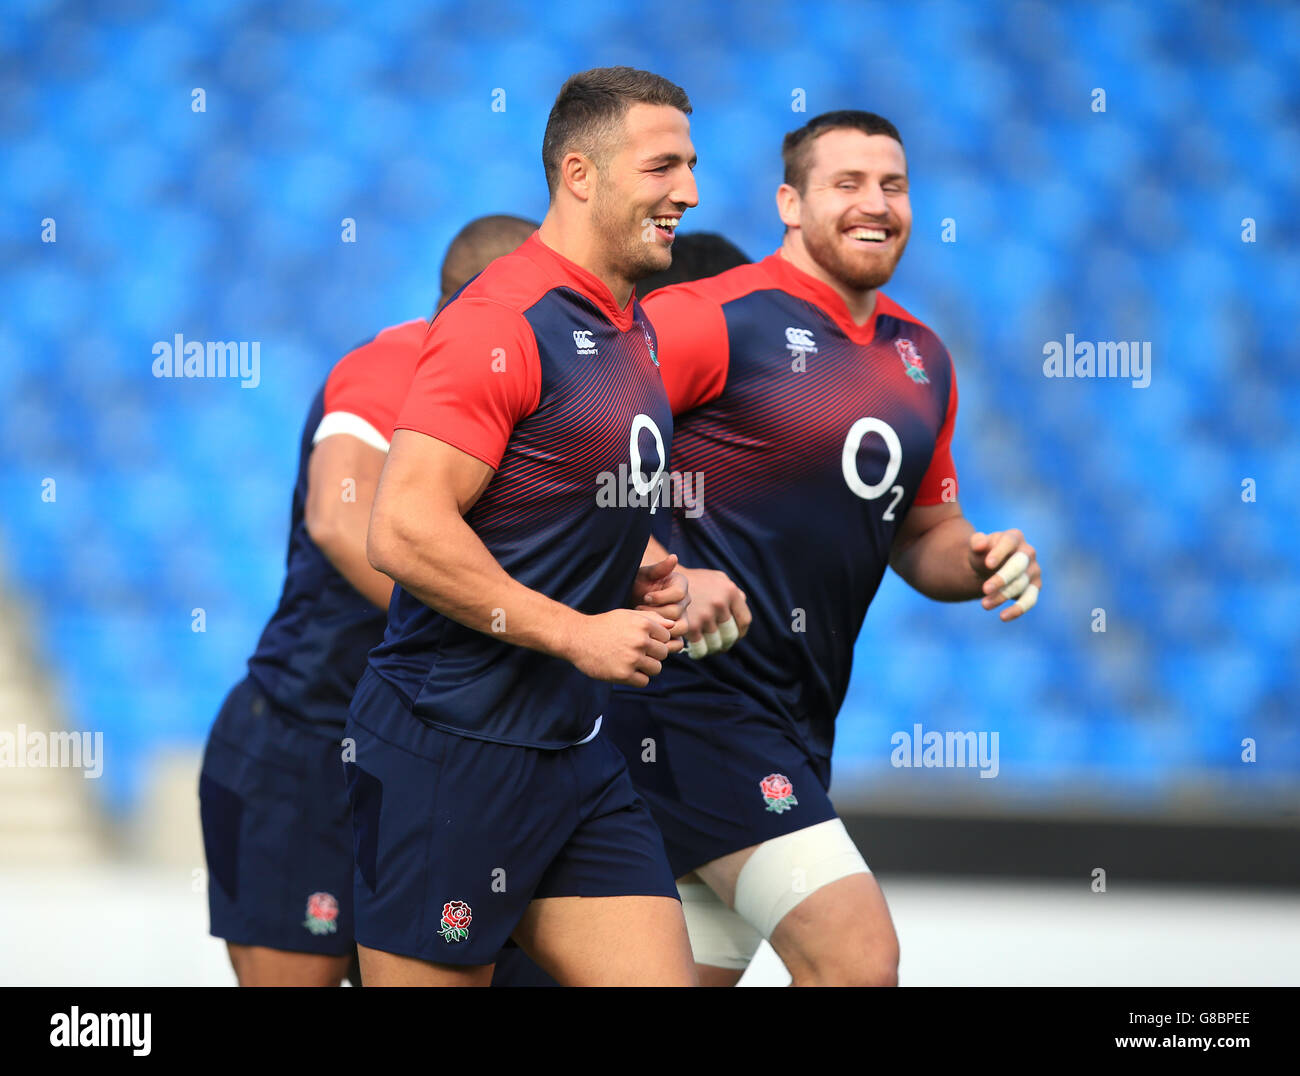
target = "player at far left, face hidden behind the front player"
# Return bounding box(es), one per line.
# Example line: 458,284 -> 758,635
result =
199,216 -> 537,986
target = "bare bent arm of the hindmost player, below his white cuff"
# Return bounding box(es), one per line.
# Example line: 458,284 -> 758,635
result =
303,434 -> 393,609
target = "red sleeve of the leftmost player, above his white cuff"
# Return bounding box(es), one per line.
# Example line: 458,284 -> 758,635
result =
324,318 -> 429,441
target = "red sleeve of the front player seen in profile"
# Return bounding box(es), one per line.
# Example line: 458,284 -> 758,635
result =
395,299 -> 542,470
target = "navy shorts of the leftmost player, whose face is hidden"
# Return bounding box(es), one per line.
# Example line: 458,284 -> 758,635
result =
199,680 -> 352,955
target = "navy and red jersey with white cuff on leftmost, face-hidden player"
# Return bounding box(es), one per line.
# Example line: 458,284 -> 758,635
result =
248,318 -> 429,730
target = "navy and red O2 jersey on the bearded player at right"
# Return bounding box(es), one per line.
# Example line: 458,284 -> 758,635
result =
629,253 -> 957,758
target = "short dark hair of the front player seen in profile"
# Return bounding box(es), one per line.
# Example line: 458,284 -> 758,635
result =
542,68 -> 690,200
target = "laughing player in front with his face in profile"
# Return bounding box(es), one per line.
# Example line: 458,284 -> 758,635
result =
345,68 -> 697,985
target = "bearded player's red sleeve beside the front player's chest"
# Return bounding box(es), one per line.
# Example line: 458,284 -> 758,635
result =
641,285 -> 729,415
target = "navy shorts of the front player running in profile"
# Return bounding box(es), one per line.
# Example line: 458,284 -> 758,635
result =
345,669 -> 677,964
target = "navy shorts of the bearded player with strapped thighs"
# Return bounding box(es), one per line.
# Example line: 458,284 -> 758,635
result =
602,690 -> 836,877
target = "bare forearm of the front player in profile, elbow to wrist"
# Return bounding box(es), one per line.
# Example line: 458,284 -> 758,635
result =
369,515 -> 581,658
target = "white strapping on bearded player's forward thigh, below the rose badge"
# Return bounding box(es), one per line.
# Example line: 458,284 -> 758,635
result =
736,819 -> 871,940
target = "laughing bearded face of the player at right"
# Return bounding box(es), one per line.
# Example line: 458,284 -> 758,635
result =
783,129 -> 911,291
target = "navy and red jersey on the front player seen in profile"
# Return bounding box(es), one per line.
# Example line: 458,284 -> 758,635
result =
371,234 -> 672,749
